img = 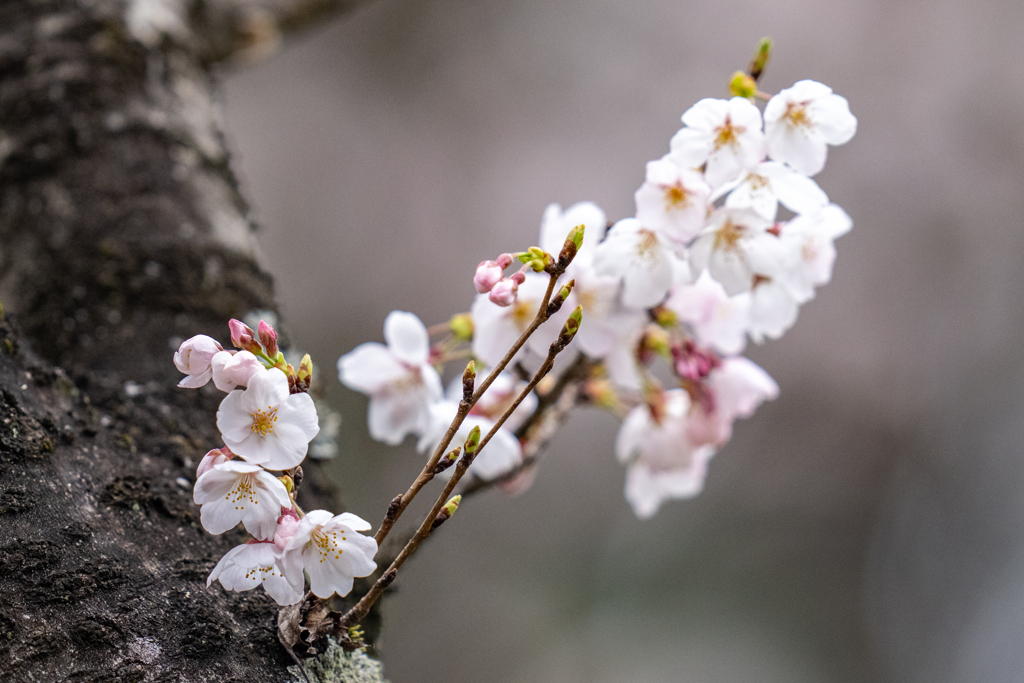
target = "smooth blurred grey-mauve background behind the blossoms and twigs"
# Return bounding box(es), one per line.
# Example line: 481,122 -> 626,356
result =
220,0 -> 1024,683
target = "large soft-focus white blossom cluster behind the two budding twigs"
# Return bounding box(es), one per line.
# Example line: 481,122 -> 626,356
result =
338,57 -> 857,517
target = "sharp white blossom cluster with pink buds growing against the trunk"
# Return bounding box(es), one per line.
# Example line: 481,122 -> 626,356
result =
174,321 -> 377,605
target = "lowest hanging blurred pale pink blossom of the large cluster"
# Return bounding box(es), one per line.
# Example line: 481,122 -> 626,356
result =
615,389 -> 715,519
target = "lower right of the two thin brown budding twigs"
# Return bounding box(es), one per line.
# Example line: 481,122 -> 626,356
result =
338,325 -> 571,628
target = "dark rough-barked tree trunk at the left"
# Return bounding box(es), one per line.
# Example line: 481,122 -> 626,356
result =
0,0 -> 366,683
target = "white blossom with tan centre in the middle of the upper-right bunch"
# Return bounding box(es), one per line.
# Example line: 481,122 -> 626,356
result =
690,209 -> 783,296
